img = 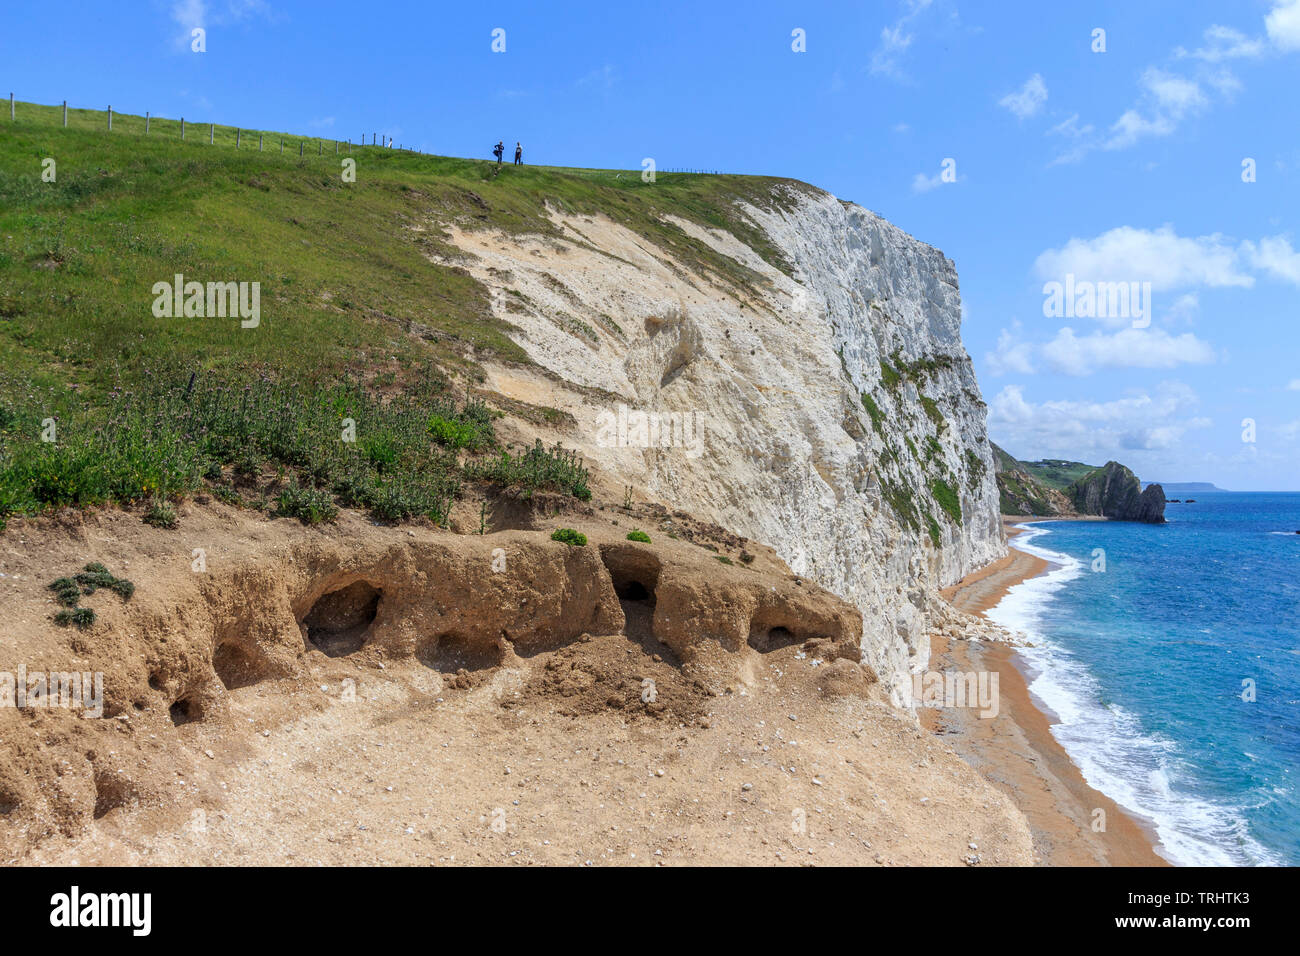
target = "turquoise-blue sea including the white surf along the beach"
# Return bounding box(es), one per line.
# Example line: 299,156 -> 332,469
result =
989,492 -> 1300,865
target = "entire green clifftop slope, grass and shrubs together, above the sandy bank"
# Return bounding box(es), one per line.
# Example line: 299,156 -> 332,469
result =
0,103 -> 807,530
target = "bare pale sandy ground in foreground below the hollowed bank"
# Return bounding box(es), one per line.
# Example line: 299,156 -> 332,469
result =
25,636 -> 1031,866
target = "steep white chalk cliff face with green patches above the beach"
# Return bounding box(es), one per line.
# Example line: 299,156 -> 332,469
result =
452,186 -> 1005,702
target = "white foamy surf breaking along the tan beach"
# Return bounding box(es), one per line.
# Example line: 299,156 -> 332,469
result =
988,524 -> 1283,866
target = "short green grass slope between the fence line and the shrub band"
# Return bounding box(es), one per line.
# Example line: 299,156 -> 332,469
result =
0,103 -> 795,395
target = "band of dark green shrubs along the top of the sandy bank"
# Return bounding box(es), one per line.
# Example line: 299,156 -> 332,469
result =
0,373 -> 592,528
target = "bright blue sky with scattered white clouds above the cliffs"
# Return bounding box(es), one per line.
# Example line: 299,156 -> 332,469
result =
0,0 -> 1300,489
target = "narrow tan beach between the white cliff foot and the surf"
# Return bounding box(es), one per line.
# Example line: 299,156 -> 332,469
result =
920,516 -> 1169,866
